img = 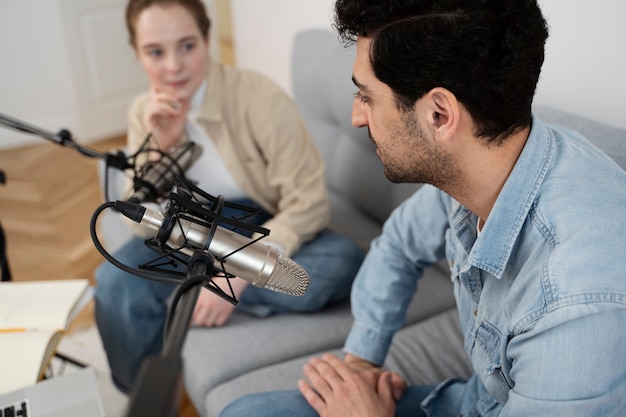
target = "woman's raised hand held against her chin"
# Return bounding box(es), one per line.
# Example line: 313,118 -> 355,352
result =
144,90 -> 190,151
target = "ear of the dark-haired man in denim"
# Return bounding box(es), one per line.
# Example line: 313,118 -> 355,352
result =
425,87 -> 460,140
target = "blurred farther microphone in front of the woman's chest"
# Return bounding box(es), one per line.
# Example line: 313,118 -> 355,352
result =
127,141 -> 202,203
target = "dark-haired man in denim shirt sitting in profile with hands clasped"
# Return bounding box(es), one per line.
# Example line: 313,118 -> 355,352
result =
223,0 -> 626,417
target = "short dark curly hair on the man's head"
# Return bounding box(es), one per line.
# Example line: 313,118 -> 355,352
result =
334,0 -> 548,143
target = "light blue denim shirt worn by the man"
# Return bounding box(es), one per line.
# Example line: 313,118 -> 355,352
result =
345,117 -> 626,417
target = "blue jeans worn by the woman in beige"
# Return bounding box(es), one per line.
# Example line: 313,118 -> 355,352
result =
95,202 -> 364,392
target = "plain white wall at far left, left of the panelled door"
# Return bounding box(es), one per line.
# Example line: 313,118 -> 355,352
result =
0,0 -> 77,150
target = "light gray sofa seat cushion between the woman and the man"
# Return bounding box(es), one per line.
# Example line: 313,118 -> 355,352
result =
183,267 -> 454,416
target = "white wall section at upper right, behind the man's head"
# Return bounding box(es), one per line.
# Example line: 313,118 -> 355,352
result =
535,0 -> 626,127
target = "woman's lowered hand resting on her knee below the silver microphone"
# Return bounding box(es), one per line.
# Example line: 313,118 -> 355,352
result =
191,278 -> 248,327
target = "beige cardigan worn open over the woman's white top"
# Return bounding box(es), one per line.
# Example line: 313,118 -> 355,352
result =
128,60 -> 330,256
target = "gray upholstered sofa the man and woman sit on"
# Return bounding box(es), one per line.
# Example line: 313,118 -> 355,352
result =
178,30 -> 626,417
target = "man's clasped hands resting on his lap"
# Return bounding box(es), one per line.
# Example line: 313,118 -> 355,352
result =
298,354 -> 396,417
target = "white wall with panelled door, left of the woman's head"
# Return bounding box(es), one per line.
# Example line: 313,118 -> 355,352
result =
0,0 -> 218,150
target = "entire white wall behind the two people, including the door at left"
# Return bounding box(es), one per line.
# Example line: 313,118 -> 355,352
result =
0,0 -> 626,153
